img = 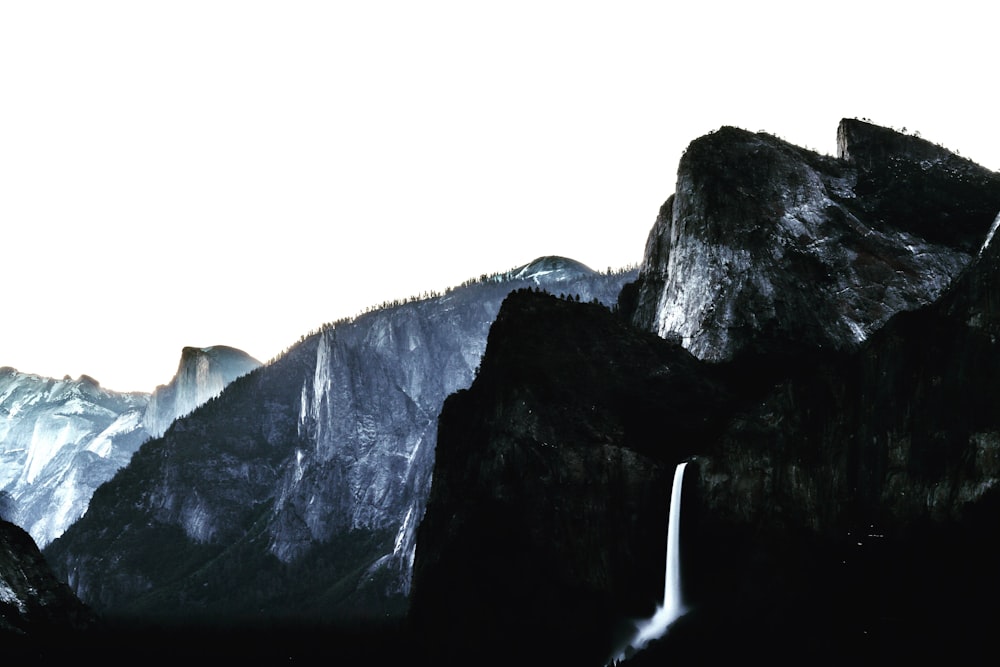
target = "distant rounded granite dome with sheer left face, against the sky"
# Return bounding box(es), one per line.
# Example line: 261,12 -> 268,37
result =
142,345 -> 260,437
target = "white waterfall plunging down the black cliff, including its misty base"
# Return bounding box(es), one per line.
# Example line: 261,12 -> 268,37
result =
614,461 -> 687,660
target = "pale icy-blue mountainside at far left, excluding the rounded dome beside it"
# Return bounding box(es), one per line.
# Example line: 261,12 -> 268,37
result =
0,368 -> 149,547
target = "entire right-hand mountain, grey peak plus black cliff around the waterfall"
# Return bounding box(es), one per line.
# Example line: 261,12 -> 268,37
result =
410,120 -> 1000,665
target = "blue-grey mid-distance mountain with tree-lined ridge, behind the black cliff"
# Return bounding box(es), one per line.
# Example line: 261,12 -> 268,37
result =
45,257 -> 636,624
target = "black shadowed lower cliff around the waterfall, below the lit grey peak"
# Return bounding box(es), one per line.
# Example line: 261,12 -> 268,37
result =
412,258 -> 1000,664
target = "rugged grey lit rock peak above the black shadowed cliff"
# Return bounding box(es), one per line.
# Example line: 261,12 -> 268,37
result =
633,120 -> 1000,361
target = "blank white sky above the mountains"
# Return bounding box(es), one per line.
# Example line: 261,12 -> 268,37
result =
0,0 -> 1000,391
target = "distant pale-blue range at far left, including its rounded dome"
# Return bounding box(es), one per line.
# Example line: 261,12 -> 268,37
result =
0,346 -> 260,548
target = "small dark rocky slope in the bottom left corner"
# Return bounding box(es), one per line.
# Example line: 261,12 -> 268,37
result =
0,521 -> 98,664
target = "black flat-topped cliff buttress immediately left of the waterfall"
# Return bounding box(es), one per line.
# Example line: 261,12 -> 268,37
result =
412,291 -> 733,664
